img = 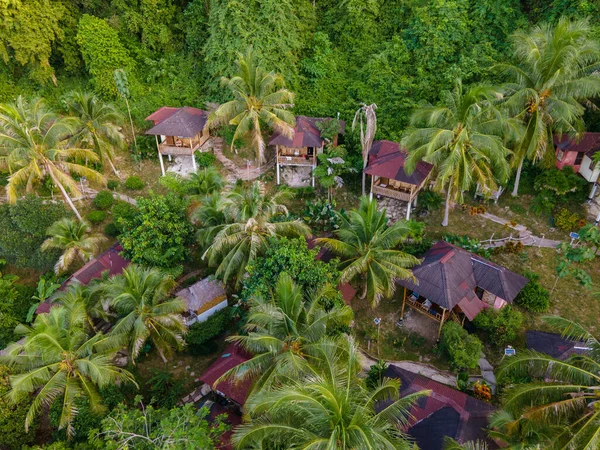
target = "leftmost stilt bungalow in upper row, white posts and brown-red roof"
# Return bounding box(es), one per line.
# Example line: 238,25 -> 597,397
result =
146,106 -> 210,176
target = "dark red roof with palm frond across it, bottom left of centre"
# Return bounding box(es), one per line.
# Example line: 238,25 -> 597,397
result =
199,344 -> 252,405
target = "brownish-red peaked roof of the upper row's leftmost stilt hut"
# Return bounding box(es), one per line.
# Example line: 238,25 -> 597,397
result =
146,106 -> 207,138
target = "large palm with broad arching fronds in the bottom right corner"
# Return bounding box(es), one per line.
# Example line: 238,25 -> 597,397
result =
499,316 -> 600,450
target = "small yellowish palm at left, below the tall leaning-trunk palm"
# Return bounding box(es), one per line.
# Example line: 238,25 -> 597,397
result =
42,217 -> 106,275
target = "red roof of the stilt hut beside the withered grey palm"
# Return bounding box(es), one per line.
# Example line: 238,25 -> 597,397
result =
365,141 -> 433,186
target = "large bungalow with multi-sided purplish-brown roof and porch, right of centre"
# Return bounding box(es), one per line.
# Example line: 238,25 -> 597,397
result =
397,241 -> 529,337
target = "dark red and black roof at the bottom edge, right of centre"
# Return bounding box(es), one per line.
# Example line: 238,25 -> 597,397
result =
385,364 -> 497,450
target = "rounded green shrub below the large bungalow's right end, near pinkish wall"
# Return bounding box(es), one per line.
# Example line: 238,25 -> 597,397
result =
473,306 -> 523,346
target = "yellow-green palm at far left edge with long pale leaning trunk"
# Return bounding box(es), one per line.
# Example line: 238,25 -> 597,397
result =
0,96 -> 106,220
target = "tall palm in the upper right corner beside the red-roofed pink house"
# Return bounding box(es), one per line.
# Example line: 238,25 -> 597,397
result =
499,18 -> 600,196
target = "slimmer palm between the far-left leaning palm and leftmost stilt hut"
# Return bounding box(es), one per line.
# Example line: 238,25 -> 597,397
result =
63,91 -> 125,176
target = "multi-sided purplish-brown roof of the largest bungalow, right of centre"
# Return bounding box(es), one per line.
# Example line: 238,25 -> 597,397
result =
398,241 -> 529,314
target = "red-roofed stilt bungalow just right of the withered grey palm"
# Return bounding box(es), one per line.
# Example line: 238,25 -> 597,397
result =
365,141 -> 433,220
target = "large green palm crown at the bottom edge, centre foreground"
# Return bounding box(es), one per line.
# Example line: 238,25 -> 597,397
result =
232,338 -> 429,450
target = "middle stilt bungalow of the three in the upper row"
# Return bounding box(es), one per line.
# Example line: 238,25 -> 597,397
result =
269,116 -> 346,187
